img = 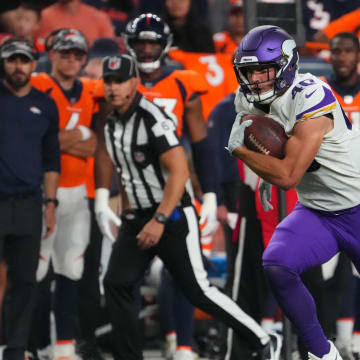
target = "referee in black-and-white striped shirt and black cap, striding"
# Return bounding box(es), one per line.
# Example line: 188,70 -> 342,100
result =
95,55 -> 276,360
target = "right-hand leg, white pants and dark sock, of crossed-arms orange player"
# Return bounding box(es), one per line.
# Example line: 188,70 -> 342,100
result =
53,185 -> 90,359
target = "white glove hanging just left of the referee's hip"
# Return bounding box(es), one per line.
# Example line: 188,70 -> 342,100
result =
95,188 -> 121,242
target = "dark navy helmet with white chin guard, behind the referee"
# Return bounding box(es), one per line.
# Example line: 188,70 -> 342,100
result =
123,13 -> 173,73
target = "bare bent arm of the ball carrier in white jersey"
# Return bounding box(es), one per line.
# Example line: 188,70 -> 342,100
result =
233,116 -> 333,190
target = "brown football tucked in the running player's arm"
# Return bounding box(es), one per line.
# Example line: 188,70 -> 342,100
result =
241,114 -> 288,159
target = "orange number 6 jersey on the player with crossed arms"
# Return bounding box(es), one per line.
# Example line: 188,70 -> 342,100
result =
31,73 -> 97,187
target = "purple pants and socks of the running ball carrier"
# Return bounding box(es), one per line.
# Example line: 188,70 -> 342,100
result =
263,203 -> 360,358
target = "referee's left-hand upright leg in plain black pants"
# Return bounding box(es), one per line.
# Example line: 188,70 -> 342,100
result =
104,212 -> 154,360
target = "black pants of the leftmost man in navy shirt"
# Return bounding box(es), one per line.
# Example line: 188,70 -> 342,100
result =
0,196 -> 42,360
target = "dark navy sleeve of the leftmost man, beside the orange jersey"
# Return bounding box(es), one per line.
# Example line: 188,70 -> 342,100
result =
42,98 -> 60,173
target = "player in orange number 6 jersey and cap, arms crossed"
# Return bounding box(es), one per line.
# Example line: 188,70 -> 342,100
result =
31,29 -> 97,360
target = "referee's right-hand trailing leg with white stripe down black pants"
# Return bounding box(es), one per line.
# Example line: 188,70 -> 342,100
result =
157,207 -> 269,350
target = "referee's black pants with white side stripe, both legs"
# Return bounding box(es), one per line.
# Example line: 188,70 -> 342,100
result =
104,206 -> 268,360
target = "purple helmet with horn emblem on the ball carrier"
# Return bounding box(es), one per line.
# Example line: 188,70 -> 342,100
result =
233,25 -> 299,104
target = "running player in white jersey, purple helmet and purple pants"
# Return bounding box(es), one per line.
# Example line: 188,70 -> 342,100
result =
228,25 -> 360,360
